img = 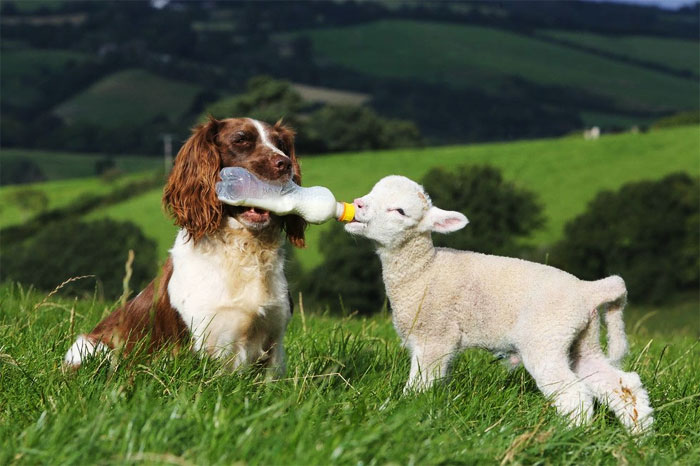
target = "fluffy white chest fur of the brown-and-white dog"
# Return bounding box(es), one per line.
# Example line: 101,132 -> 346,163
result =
168,218 -> 291,373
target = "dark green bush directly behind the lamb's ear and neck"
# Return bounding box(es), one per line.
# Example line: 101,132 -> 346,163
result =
423,166 -> 544,255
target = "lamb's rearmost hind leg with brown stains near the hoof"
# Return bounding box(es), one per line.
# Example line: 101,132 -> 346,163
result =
576,352 -> 654,434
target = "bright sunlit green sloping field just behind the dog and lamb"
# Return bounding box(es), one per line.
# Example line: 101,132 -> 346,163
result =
86,127 -> 700,267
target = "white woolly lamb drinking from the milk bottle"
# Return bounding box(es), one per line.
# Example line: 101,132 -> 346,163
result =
345,176 -> 653,434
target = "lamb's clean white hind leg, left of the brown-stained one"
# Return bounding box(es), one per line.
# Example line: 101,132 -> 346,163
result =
521,348 -> 593,425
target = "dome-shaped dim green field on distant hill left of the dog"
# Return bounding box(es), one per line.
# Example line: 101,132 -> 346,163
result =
55,69 -> 200,128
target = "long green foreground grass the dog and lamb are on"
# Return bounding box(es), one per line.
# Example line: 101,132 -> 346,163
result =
0,285 -> 700,465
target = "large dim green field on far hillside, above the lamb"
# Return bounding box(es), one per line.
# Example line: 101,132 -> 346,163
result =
303,20 -> 698,111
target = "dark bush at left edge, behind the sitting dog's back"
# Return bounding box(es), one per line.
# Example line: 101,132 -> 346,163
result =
2,219 -> 157,299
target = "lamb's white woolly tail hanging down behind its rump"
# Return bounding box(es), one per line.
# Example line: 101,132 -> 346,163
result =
591,275 -> 627,367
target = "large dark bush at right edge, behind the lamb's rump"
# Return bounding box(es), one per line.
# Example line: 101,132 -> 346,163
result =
552,173 -> 700,303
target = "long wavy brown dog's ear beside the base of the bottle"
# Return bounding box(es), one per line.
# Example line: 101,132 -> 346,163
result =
163,116 -> 223,242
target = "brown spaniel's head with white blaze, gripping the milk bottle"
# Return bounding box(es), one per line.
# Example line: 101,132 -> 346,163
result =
163,117 -> 306,247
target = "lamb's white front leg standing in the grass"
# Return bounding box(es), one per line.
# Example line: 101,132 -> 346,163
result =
403,343 -> 455,393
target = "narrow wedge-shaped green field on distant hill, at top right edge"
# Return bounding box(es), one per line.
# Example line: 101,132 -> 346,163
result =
539,30 -> 700,76
